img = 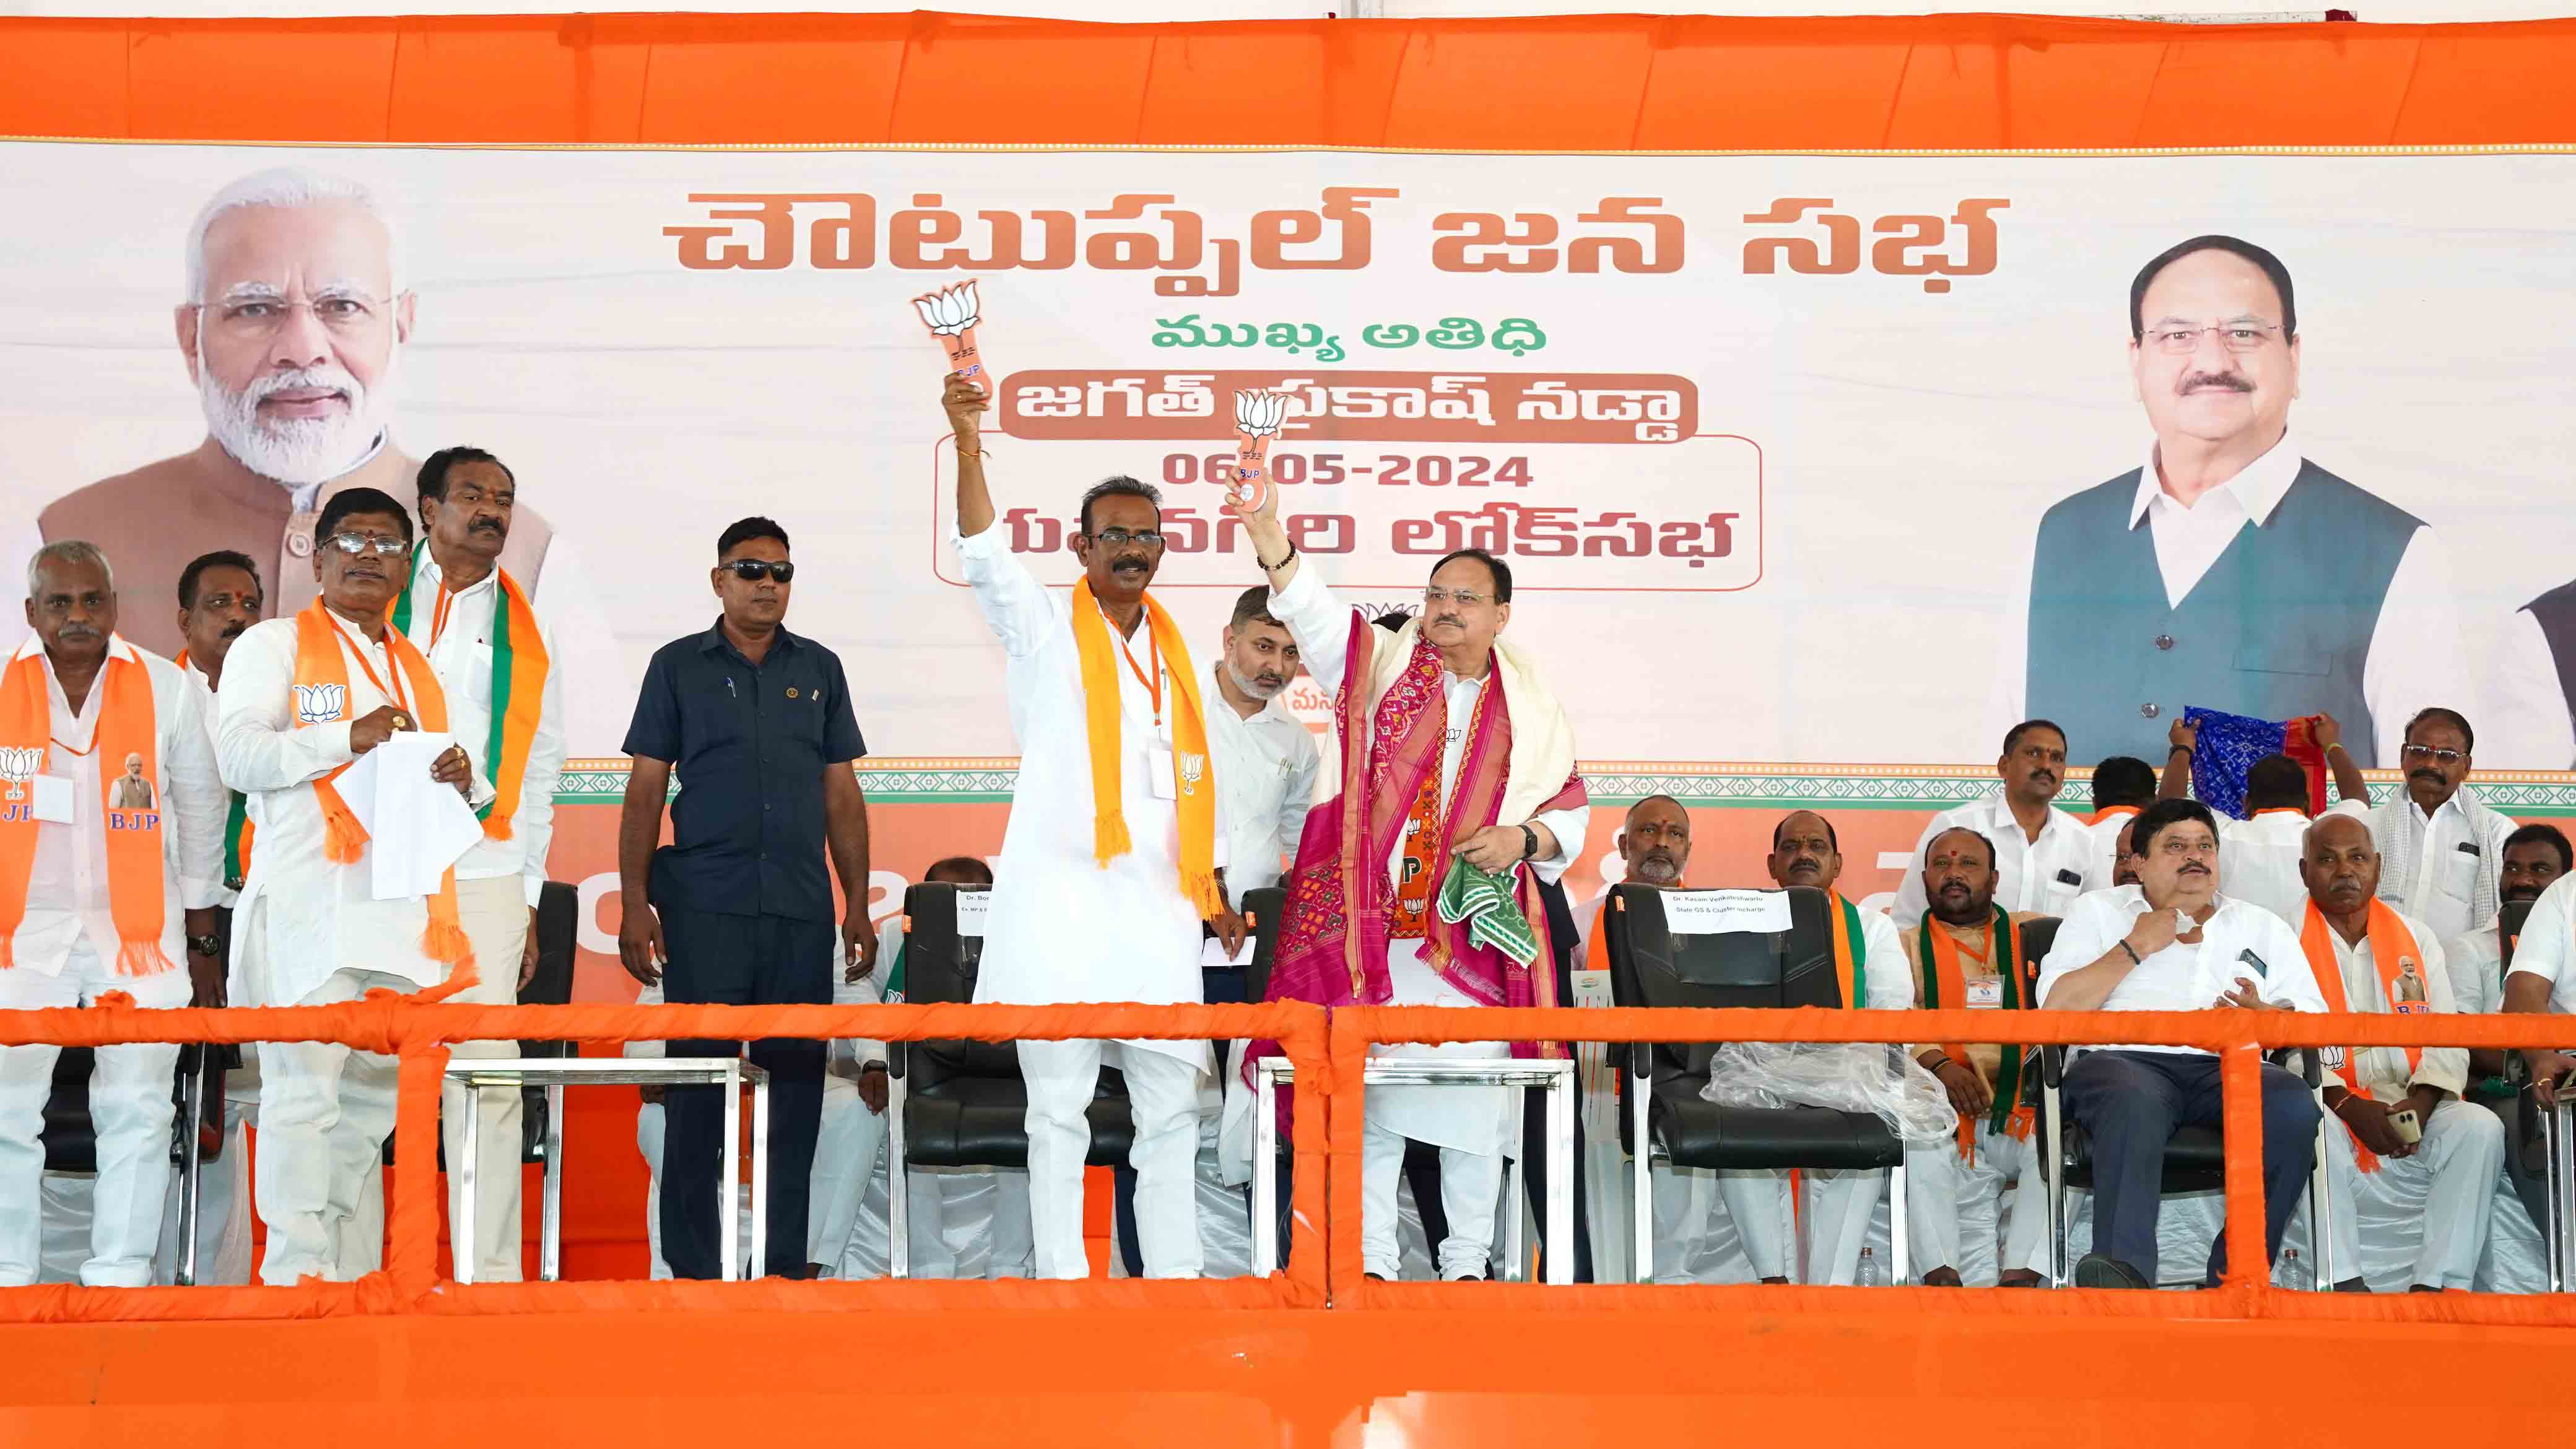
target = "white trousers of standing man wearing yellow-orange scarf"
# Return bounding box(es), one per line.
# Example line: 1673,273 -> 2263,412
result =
1020,1042 -> 1206,1279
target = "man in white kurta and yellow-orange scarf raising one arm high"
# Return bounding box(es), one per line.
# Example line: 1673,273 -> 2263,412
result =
943,374 -> 1244,1279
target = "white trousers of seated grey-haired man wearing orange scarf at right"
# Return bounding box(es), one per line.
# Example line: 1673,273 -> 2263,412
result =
2282,1101 -> 2504,1292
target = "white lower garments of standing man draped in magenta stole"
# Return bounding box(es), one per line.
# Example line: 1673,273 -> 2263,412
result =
1360,941 -> 1512,1279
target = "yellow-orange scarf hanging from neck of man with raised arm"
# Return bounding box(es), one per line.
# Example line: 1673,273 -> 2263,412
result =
1074,580 -> 1226,920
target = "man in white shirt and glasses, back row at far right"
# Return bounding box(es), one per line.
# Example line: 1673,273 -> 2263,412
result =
2334,707 -> 2514,941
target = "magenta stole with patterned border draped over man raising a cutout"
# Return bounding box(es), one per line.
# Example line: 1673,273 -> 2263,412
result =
1250,603 -> 1590,1067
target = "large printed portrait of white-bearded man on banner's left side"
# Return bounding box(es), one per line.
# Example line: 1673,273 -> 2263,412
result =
15,168 -> 606,670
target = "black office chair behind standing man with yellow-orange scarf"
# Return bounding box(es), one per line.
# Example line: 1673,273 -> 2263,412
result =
886,882 -> 1136,1279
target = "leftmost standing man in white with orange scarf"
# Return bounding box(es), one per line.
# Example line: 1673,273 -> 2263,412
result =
0,539 -> 224,1287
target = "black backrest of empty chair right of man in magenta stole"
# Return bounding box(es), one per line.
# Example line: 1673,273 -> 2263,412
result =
1603,884 -> 1860,1077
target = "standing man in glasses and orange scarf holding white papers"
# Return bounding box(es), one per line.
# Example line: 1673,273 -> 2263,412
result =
216,487 -> 484,1284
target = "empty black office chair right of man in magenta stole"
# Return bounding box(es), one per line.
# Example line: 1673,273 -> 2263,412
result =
1603,884 -> 1906,1281
